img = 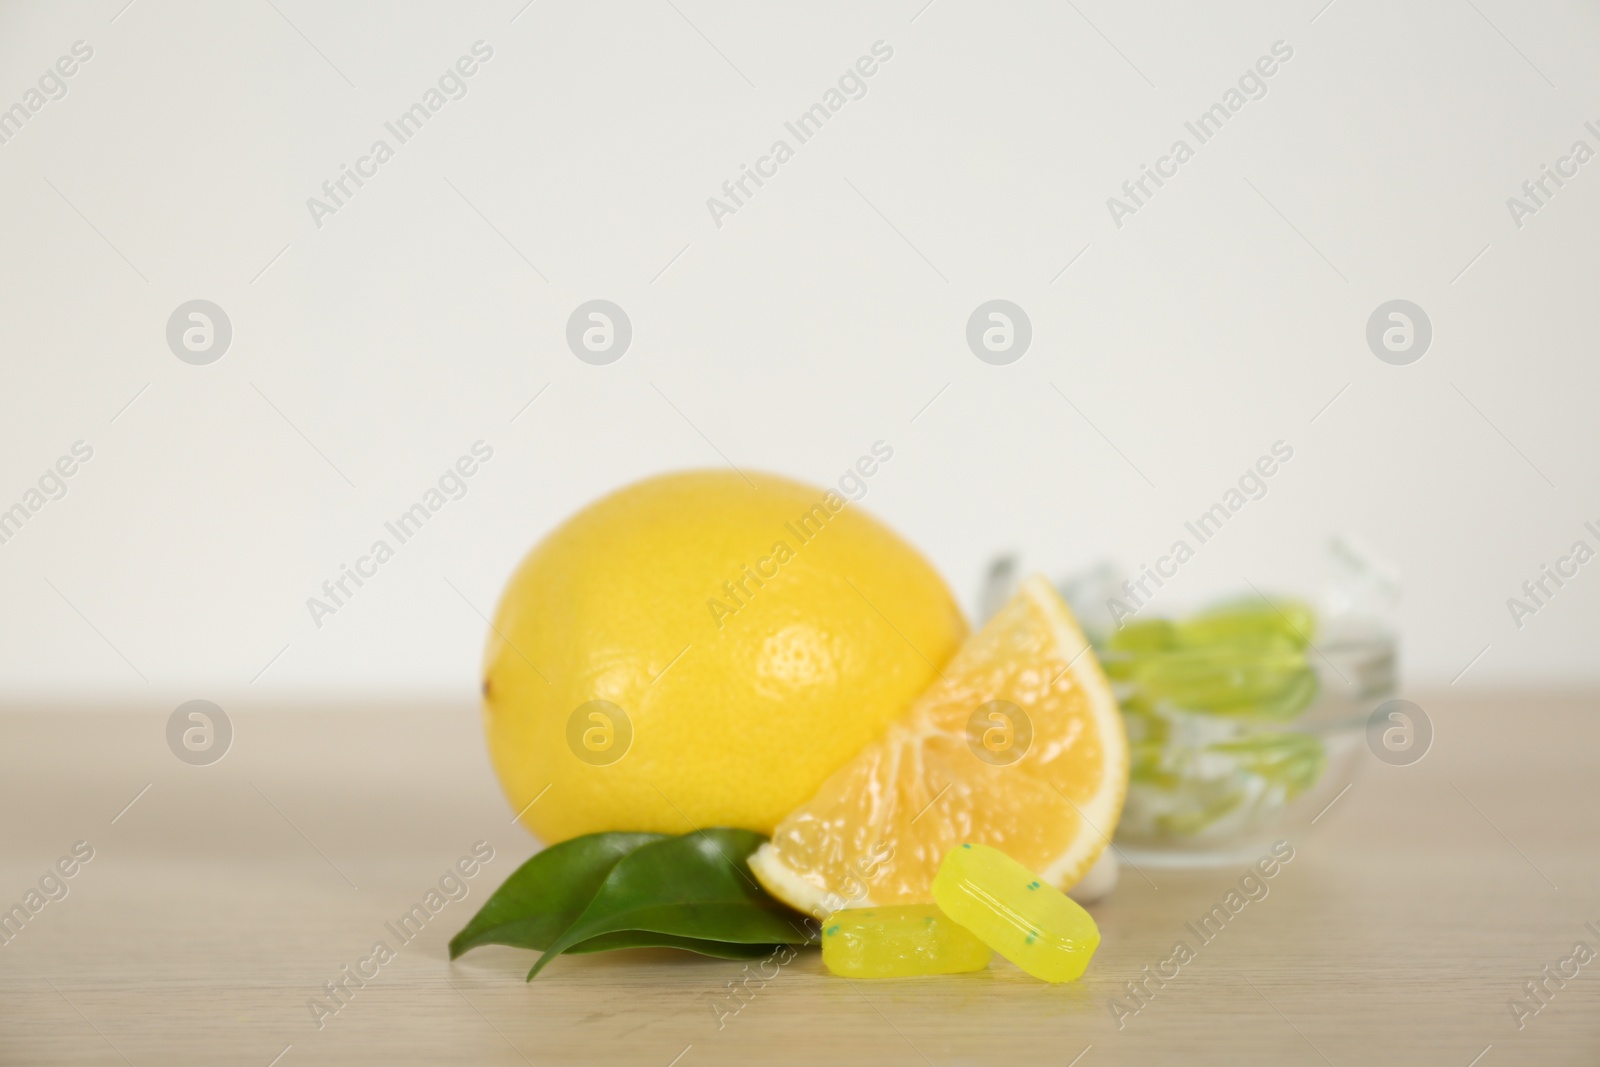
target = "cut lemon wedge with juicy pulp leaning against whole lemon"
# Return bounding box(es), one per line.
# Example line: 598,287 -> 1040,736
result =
750,574 -> 1128,915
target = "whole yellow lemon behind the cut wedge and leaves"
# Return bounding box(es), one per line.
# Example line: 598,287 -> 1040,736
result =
483,467 -> 966,843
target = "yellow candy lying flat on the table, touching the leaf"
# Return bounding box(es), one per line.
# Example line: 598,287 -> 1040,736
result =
822,904 -> 994,977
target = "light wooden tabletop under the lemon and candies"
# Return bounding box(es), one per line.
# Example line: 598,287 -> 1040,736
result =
0,694 -> 1600,1067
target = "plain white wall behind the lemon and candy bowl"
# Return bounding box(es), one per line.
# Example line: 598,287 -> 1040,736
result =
0,0 -> 1600,707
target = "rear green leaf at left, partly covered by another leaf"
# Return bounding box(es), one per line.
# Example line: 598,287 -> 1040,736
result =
450,833 -> 667,960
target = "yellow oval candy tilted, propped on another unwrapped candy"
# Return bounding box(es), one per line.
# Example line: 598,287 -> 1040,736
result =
933,845 -> 1099,982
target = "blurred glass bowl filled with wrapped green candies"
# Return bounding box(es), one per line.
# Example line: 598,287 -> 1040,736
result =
984,542 -> 1398,867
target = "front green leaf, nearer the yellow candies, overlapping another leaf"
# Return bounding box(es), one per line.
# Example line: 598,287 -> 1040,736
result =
528,829 -> 810,979
